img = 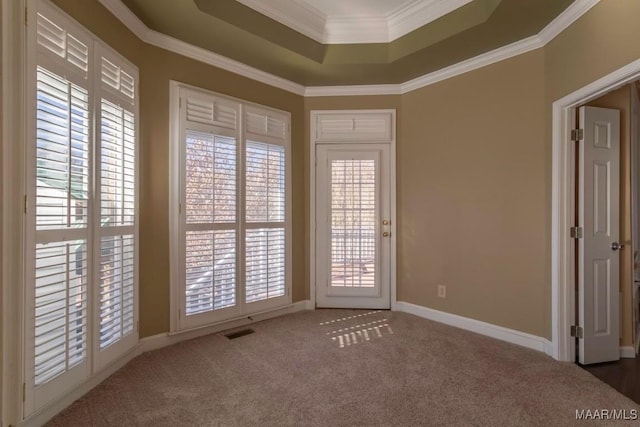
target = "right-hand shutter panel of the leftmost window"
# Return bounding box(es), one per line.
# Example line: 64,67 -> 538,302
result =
95,46 -> 137,366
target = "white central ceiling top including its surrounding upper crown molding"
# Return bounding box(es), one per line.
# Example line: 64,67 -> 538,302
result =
237,0 -> 472,44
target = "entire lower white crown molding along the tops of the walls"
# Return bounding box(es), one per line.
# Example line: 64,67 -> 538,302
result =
99,0 -> 600,97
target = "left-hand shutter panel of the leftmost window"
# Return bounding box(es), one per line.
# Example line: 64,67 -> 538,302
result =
27,62 -> 90,404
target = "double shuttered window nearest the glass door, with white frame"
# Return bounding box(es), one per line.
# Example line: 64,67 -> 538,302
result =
171,83 -> 291,329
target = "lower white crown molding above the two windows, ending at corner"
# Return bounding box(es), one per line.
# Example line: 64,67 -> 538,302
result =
99,0 -> 304,95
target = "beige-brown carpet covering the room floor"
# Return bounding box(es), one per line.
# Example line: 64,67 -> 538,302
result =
49,310 -> 640,426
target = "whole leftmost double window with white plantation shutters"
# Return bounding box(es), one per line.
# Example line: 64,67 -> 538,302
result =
25,0 -> 138,415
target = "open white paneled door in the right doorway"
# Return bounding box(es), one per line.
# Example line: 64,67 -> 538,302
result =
578,107 -> 621,364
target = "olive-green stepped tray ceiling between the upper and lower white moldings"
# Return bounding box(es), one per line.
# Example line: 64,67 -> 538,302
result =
122,0 -> 573,86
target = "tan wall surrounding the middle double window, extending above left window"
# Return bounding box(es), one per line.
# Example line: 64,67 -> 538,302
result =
55,0 -> 309,337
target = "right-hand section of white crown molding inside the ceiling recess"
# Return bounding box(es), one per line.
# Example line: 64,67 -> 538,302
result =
388,0 -> 472,42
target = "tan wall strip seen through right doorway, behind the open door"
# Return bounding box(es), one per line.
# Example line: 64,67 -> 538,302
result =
586,85 -> 634,346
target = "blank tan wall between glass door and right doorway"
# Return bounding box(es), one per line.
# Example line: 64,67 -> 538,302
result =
398,50 -> 549,336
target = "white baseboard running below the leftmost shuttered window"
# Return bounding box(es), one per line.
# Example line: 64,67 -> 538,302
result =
18,345 -> 141,427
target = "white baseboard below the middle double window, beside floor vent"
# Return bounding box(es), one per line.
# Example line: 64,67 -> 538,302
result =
138,300 -> 310,353
